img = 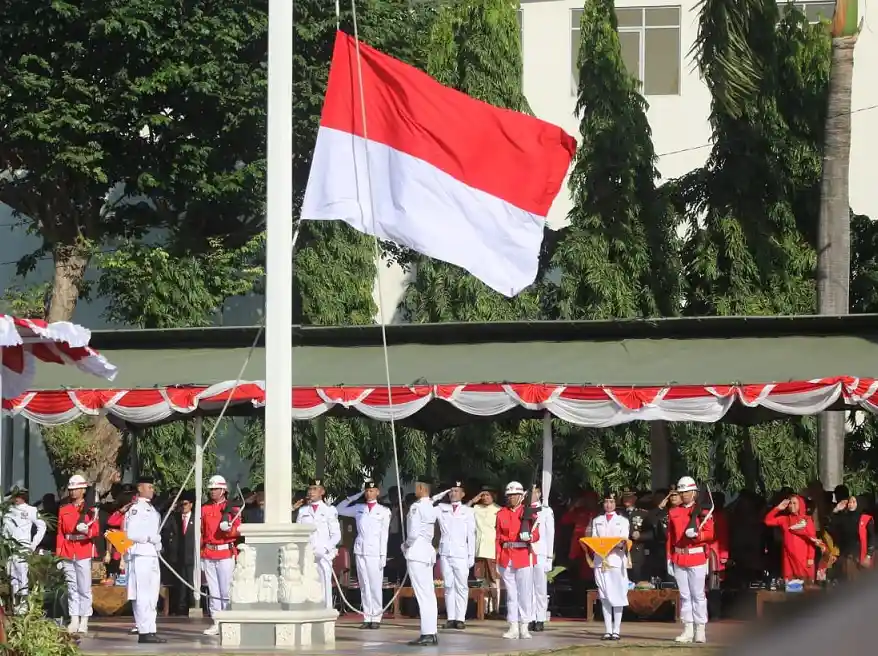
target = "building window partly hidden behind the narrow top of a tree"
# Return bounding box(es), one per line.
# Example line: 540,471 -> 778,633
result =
570,7 -> 681,96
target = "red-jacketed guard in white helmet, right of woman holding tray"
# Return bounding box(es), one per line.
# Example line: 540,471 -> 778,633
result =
666,476 -> 715,643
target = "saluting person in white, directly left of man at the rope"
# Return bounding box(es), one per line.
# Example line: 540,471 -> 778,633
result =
338,481 -> 390,629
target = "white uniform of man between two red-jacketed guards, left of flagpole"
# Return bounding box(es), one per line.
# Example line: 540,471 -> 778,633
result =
123,499 -> 162,635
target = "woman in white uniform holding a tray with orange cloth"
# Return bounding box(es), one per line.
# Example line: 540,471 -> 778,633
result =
589,492 -> 631,640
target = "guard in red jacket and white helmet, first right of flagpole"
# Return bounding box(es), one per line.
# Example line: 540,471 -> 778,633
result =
497,481 -> 540,640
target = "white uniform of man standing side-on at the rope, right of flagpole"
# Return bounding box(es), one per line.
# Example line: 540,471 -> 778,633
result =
402,497 -> 439,636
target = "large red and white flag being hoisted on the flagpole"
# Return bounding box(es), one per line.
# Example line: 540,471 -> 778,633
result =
302,32 -> 576,296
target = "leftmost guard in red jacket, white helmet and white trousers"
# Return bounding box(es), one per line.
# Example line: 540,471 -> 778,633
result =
55,474 -> 100,635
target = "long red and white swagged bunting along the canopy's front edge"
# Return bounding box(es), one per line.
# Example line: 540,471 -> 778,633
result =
3,377 -> 878,428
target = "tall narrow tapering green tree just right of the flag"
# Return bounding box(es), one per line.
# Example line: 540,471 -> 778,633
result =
551,0 -> 680,319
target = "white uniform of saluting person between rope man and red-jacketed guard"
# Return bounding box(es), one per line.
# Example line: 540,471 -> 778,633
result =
436,502 -> 476,622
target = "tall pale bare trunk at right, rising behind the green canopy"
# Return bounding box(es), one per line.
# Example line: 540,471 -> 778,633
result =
817,33 -> 857,490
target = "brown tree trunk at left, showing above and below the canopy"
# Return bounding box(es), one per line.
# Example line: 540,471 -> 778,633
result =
46,245 -> 122,494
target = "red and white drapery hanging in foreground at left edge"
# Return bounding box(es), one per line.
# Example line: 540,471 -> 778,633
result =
0,314 -> 116,399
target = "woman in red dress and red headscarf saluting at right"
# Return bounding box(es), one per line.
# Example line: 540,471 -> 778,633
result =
765,495 -> 817,581
